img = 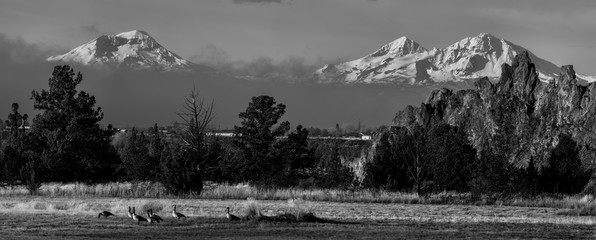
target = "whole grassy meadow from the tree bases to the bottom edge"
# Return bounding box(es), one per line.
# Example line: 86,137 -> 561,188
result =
0,183 -> 596,239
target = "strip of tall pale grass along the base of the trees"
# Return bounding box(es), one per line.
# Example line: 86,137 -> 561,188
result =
0,182 -> 596,209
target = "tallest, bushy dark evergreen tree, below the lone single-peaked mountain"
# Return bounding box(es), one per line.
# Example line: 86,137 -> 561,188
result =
31,65 -> 117,182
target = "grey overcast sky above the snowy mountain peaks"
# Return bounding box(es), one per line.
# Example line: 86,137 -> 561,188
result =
0,0 -> 596,75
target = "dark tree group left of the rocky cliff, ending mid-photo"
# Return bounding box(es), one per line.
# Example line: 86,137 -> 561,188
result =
0,65 -> 353,194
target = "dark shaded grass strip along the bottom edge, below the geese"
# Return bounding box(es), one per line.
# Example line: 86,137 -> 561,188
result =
0,215 -> 595,239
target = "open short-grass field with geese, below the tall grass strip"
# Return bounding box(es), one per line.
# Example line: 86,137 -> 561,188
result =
0,197 -> 596,239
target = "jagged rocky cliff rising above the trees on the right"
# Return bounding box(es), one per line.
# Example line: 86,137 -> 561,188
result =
392,52 -> 596,170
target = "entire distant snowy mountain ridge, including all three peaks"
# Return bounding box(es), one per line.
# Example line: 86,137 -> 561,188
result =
46,30 -> 596,84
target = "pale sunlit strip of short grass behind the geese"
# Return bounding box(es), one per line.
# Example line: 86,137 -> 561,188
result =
0,197 -> 596,225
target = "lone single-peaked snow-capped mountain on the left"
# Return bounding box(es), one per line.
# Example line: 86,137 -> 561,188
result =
47,30 -> 213,71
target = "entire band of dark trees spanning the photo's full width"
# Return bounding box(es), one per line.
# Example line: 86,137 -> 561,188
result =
0,65 -> 593,196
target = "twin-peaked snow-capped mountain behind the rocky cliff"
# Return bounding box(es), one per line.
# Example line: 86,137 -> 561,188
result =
313,33 -> 596,85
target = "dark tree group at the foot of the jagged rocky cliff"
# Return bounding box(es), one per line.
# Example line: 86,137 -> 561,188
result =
363,115 -> 594,199
